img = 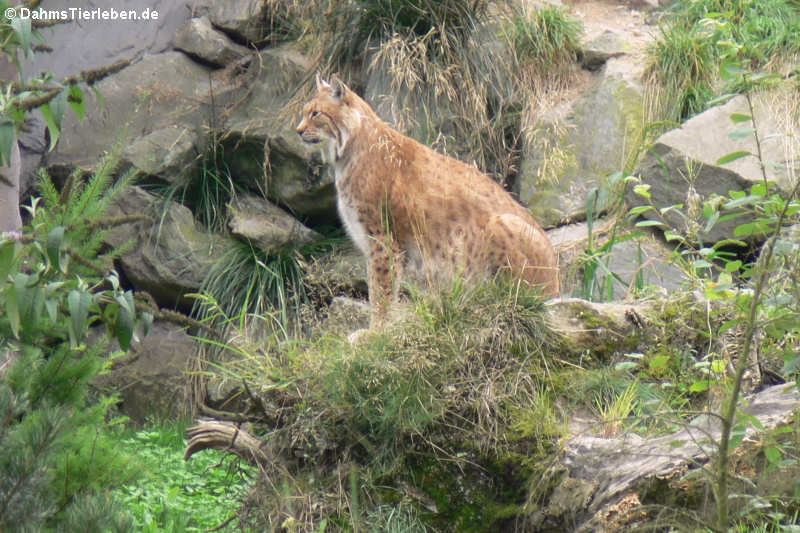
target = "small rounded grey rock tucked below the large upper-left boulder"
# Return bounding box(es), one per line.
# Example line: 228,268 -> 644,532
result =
122,126 -> 200,184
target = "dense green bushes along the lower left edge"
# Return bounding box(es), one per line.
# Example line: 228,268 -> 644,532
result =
0,149 -> 148,531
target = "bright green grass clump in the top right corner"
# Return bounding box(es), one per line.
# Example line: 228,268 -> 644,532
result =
647,0 -> 800,120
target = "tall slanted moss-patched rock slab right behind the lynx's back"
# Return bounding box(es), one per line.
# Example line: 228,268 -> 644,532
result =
515,58 -> 644,228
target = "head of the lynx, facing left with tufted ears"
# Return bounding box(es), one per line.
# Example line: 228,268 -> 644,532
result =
297,74 -> 366,162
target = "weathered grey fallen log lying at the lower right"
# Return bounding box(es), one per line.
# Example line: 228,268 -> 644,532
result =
532,383 -> 800,532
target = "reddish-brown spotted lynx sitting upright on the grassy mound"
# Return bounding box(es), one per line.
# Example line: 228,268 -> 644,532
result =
297,76 -> 558,328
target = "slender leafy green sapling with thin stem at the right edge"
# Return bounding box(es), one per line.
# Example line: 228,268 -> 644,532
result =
630,68 -> 800,531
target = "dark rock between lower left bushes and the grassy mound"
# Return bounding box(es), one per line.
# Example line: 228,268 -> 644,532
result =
93,320 -> 201,424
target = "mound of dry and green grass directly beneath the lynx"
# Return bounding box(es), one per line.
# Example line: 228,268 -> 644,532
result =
195,280 -> 560,531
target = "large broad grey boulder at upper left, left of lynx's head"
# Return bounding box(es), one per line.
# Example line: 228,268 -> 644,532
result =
46,52 -> 233,171
